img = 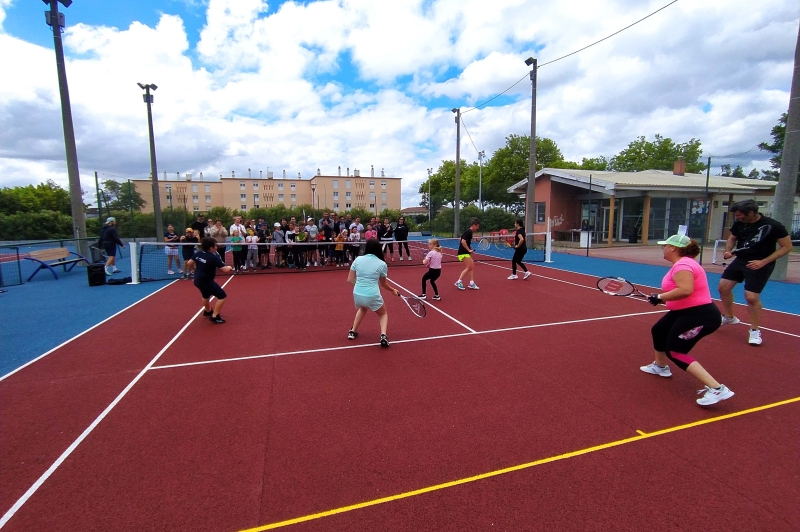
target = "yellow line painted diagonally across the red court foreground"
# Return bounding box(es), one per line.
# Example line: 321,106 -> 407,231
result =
242,397 -> 800,532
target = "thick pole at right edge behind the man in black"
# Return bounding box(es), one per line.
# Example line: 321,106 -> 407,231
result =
772,22 -> 800,281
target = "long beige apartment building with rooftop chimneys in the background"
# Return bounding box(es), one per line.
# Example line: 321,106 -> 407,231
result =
132,170 -> 402,214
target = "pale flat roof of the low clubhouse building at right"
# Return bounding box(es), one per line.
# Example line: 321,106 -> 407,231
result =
508,168 -> 778,194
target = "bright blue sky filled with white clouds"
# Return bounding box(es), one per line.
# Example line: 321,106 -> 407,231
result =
0,0 -> 800,207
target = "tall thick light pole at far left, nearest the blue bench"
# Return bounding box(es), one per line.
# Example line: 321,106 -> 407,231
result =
42,0 -> 89,256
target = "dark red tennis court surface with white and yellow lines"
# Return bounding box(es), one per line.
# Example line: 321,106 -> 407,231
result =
0,264 -> 800,531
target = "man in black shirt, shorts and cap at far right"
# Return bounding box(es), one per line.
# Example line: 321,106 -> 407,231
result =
718,200 -> 792,345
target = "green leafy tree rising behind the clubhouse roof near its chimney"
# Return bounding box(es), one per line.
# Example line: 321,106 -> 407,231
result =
608,134 -> 706,173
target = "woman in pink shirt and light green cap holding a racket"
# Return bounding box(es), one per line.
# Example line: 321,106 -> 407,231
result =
640,235 -> 733,406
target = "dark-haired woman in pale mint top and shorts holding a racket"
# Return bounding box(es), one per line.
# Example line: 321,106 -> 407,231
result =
347,238 -> 400,347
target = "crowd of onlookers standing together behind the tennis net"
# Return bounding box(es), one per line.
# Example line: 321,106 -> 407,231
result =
164,212 -> 418,277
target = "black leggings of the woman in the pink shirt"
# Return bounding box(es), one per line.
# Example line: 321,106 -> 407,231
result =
650,303 -> 722,371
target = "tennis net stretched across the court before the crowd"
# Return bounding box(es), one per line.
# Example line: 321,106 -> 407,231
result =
131,233 -> 551,281
